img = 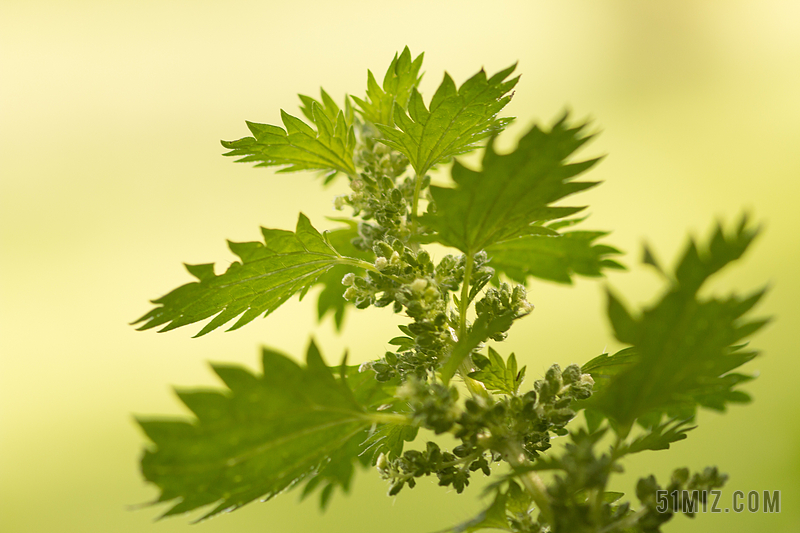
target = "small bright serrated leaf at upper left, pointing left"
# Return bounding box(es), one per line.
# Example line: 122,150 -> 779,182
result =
222,91 -> 356,176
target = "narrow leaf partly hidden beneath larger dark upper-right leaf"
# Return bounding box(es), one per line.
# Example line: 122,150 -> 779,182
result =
486,231 -> 625,284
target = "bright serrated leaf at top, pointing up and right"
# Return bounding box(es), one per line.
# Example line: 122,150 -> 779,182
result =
377,65 -> 519,176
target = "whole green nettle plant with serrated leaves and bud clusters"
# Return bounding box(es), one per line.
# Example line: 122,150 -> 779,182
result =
137,48 -> 766,533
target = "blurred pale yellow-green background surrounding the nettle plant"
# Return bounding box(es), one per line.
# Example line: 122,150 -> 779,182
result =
0,0 -> 800,533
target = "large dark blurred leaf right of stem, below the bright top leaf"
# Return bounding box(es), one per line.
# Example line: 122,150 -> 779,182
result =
423,114 -> 600,254
